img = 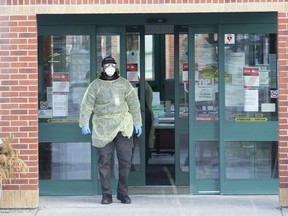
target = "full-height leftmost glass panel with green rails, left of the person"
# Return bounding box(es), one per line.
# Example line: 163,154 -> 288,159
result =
38,29 -> 95,195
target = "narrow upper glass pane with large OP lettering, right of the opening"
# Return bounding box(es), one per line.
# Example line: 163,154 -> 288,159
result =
195,33 -> 218,121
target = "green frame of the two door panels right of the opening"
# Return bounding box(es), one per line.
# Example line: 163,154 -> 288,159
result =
187,24 -> 278,194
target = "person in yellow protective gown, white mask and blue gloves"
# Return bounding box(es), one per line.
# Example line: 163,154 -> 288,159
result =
79,57 -> 142,204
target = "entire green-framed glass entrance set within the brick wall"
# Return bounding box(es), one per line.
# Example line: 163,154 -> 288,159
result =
38,13 -> 278,195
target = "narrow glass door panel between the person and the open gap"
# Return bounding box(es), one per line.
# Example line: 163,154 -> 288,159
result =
123,26 -> 145,186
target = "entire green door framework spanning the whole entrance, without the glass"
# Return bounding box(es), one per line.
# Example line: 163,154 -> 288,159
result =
37,13 -> 278,195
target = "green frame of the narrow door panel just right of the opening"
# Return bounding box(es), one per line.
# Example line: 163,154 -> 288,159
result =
188,25 -> 220,194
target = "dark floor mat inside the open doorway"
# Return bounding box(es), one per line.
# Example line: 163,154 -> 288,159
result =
146,164 -> 175,185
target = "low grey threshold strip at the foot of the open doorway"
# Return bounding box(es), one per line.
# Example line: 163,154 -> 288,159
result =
129,185 -> 190,195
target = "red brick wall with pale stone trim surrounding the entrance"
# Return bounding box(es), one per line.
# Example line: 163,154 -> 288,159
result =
0,0 -> 288,208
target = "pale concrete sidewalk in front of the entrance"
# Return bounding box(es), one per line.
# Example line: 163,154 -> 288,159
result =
0,195 -> 288,216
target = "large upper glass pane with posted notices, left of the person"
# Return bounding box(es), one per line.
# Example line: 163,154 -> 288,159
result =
39,35 -> 90,120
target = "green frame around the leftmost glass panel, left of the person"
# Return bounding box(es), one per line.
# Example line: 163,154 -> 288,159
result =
38,26 -> 98,195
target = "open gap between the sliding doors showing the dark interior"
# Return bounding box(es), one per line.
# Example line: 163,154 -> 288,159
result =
145,34 -> 175,185
